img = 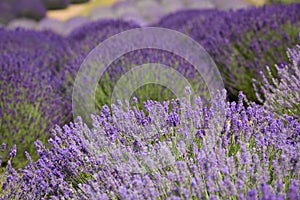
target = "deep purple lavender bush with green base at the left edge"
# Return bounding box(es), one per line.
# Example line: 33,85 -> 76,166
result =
0,29 -> 72,167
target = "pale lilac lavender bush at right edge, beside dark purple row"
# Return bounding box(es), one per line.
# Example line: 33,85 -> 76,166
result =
254,46 -> 300,118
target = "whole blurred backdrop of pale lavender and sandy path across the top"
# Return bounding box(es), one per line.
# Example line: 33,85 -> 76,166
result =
0,0 -> 270,35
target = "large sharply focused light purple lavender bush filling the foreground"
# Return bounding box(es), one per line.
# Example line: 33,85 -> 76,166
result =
2,93 -> 300,199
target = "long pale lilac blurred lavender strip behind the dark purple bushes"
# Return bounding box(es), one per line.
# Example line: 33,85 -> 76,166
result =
7,0 -> 250,35
